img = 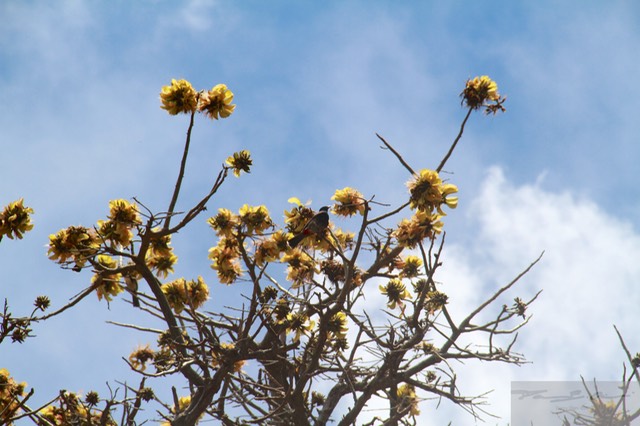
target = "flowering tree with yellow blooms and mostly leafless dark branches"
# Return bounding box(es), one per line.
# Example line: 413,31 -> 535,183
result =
0,76 -> 539,425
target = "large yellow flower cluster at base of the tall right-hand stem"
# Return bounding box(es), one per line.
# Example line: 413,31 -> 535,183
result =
407,169 -> 458,216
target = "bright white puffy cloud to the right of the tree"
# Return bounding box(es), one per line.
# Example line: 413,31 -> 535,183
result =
424,168 -> 640,424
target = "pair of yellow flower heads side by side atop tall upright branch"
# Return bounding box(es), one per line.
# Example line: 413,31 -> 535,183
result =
160,79 -> 236,120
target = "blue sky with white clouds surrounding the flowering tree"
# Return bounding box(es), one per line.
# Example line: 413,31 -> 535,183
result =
0,0 -> 640,424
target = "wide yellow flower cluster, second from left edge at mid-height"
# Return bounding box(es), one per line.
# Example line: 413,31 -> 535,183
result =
47,226 -> 100,270
